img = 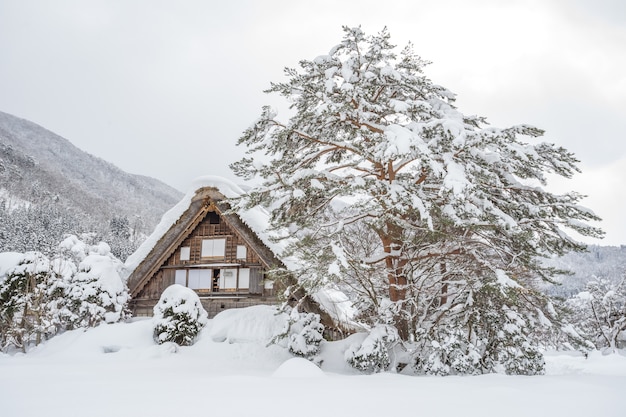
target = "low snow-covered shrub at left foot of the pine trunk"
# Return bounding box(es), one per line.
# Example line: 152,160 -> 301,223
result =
345,325 -> 399,373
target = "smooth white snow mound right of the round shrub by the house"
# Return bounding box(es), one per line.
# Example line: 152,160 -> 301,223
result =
208,305 -> 289,343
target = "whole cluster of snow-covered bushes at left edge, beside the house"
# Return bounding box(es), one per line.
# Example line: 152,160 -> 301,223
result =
0,235 -> 130,351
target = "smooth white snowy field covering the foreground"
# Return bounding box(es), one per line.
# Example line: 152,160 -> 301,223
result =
0,308 -> 626,417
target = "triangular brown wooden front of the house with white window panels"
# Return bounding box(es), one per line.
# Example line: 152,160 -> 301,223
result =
128,187 -> 282,317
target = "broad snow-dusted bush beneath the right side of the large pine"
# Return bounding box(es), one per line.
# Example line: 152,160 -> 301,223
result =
410,282 -> 550,375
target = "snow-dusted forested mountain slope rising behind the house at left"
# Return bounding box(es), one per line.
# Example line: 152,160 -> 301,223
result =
0,112 -> 182,257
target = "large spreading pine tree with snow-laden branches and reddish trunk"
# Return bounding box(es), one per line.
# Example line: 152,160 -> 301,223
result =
232,27 -> 602,372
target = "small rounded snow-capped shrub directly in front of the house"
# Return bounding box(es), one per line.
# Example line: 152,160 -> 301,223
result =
153,284 -> 208,346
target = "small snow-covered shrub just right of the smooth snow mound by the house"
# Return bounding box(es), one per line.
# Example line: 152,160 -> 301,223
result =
287,309 -> 324,359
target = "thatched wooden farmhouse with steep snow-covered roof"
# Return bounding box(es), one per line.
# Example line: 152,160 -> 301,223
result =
125,177 -> 351,328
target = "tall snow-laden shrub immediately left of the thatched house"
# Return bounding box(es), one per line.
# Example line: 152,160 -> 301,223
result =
62,236 -> 130,328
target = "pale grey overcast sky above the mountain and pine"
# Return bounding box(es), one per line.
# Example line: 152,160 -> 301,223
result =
0,0 -> 626,245
